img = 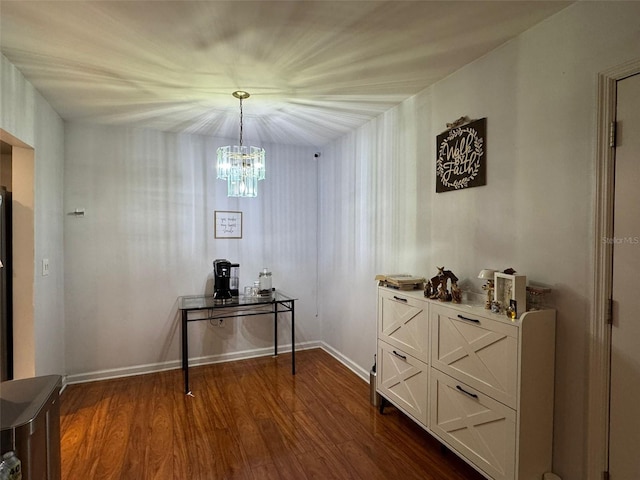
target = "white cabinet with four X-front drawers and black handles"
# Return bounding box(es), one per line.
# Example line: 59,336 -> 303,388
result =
377,287 -> 555,480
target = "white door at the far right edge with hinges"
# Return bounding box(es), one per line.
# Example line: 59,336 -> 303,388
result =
607,74 -> 640,480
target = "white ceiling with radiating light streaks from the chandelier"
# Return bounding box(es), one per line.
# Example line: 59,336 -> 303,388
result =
0,0 -> 569,147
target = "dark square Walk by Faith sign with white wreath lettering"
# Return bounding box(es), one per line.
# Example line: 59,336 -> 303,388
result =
436,117 -> 487,193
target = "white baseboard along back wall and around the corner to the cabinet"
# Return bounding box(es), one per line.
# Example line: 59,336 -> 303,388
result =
63,342 -> 322,389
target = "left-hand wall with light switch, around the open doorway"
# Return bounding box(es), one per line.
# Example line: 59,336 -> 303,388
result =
0,55 -> 65,375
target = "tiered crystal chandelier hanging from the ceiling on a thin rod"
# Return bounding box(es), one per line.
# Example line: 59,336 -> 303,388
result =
217,91 -> 265,197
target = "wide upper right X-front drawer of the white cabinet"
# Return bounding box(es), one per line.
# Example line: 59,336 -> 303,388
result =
431,305 -> 518,408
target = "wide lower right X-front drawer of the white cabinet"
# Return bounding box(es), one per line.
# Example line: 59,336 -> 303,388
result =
429,369 -> 516,480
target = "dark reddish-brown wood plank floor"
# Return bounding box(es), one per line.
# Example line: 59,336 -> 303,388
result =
60,349 -> 482,480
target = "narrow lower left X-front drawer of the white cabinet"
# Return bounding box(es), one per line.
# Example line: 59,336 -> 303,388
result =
376,341 -> 429,426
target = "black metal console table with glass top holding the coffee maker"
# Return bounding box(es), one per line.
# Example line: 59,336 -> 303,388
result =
178,291 -> 296,395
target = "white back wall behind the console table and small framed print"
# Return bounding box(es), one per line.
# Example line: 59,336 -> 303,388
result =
64,123 -> 319,381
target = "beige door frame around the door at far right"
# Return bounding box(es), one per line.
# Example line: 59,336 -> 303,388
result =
586,59 -> 640,480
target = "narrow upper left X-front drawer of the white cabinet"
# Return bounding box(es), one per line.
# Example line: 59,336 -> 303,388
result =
378,289 -> 429,362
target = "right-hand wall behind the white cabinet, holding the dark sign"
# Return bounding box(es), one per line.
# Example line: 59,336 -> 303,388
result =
319,2 -> 640,480
